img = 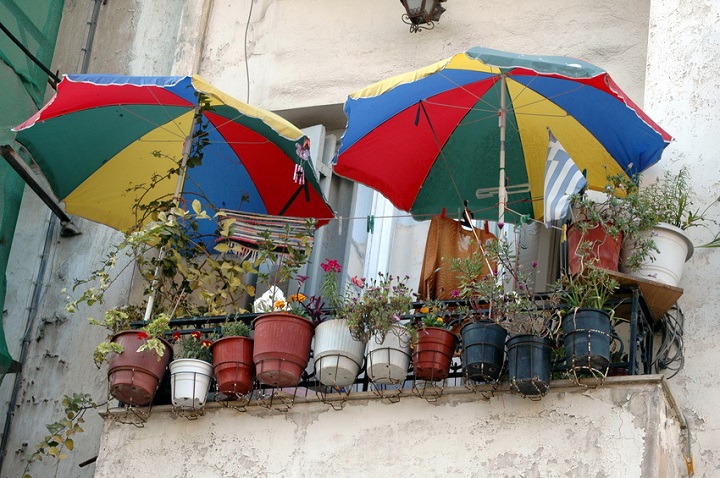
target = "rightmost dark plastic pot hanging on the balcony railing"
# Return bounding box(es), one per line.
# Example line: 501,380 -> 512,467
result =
562,309 -> 612,375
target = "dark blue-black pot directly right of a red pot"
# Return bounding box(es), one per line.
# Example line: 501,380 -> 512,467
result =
460,322 -> 507,382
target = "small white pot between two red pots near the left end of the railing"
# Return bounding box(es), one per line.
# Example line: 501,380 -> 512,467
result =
170,359 -> 213,409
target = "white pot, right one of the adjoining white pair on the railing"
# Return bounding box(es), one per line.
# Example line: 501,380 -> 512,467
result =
366,325 -> 411,385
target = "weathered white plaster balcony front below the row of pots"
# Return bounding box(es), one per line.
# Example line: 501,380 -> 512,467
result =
95,376 -> 685,478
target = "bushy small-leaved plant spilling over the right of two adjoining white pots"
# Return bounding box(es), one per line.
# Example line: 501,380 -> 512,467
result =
336,273 -> 413,342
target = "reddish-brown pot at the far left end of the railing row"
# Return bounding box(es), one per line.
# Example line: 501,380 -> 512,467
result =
108,330 -> 172,406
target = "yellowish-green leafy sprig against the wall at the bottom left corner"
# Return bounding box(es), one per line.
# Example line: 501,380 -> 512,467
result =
23,393 -> 97,478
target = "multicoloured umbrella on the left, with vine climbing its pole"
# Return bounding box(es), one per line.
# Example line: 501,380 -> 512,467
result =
14,75 -> 333,231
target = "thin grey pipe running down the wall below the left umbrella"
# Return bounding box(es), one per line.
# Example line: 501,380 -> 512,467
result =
0,216 -> 57,470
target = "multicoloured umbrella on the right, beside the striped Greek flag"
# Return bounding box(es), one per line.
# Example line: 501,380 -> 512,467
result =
335,47 -> 671,222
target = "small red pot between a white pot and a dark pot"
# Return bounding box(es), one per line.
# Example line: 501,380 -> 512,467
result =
413,327 -> 457,381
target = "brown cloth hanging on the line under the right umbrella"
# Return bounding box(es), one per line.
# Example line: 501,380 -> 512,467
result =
418,215 -> 497,300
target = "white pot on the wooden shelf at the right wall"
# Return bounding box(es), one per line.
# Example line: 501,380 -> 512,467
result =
621,222 -> 694,287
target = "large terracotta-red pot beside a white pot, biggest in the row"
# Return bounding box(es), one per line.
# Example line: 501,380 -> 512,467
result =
253,313 -> 314,387
